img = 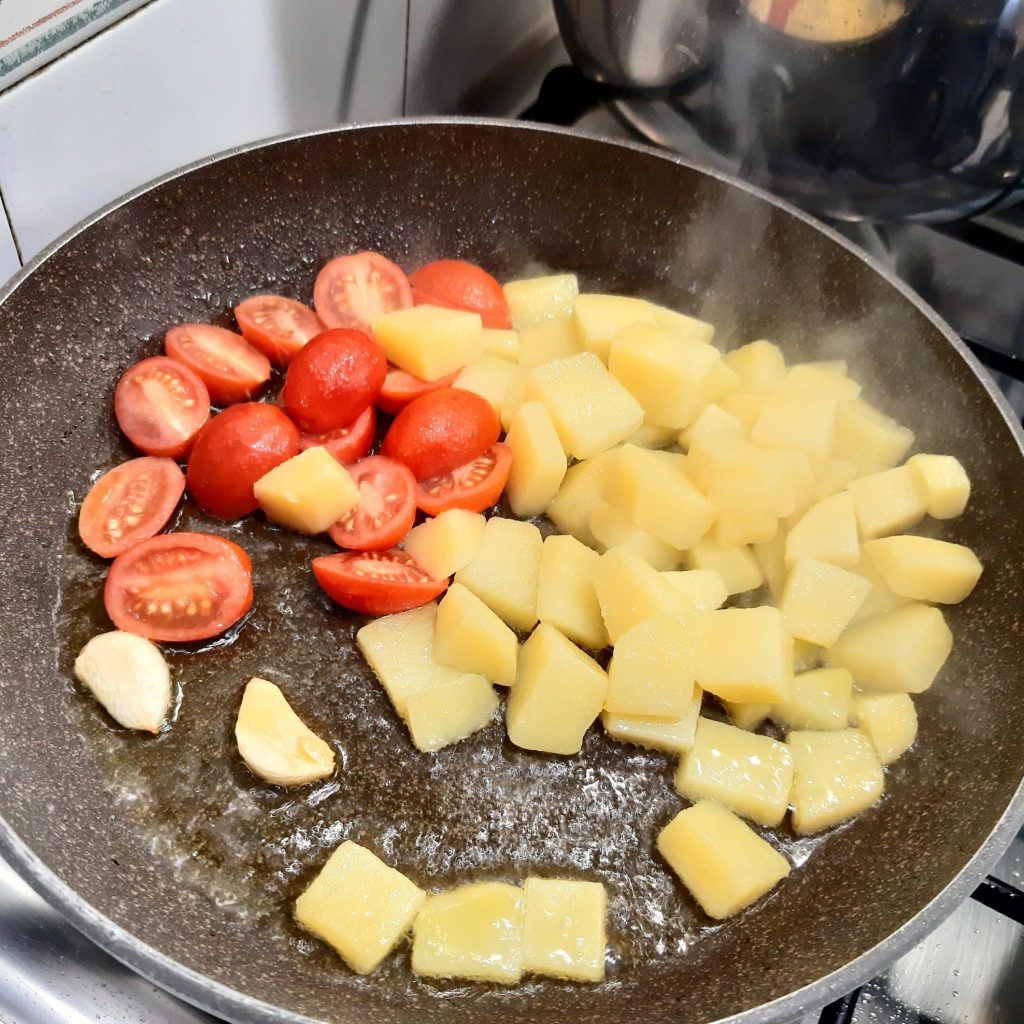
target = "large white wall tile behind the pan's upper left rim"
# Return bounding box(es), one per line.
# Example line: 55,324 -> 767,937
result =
0,0 -> 407,259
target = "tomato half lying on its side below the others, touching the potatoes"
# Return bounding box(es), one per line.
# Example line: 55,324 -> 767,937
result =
313,548 -> 447,615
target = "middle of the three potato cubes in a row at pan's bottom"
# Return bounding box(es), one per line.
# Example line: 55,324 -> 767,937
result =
413,880 -> 525,985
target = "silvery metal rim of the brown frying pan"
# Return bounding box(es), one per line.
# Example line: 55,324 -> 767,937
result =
0,116 -> 1024,1024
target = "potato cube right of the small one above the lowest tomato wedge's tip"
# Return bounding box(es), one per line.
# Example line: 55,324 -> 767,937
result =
455,516 -> 543,632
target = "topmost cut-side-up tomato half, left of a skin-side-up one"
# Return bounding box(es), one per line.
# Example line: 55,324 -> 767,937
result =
313,252 -> 413,331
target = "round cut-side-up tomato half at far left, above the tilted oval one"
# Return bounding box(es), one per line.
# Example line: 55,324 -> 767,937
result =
114,355 -> 210,459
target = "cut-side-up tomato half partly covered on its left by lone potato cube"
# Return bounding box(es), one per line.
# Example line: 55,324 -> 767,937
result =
328,455 -> 416,551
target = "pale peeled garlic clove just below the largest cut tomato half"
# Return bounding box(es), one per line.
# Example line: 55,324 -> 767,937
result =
75,630 -> 171,732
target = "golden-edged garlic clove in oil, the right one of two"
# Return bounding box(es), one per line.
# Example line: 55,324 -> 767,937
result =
234,678 -> 334,785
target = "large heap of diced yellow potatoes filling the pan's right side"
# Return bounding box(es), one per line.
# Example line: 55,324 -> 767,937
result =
296,274 -> 982,981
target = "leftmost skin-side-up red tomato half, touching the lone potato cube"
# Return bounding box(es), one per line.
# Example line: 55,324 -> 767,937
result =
185,401 -> 299,519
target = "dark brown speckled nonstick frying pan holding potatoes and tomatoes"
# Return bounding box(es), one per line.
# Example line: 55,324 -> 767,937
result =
0,120 -> 1024,1024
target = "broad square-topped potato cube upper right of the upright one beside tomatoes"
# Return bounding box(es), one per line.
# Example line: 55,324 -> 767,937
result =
526,352 -> 643,459
